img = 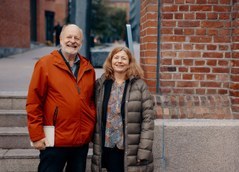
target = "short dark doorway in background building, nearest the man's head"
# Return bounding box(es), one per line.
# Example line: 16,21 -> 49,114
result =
45,11 -> 55,43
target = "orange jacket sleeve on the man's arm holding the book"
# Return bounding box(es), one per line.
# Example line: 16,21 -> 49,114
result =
26,60 -> 47,142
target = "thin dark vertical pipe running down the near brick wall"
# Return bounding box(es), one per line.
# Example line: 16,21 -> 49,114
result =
156,0 -> 161,94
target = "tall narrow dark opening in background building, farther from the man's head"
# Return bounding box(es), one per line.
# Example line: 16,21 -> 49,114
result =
30,0 -> 37,42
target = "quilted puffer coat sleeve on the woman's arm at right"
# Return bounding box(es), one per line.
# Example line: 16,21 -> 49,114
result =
137,82 -> 155,161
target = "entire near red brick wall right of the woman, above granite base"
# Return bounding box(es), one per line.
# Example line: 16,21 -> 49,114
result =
140,0 -> 239,119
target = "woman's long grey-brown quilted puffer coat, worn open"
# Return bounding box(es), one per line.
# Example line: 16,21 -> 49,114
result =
91,75 -> 155,172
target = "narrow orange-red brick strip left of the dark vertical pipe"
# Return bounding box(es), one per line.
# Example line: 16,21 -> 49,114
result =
140,0 -> 158,92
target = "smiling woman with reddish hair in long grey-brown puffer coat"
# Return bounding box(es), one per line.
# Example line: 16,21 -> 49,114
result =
91,47 -> 155,172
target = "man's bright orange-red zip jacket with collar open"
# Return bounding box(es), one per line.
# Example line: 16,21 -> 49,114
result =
26,50 -> 96,147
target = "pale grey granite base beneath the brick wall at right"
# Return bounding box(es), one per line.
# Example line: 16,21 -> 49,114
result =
154,119 -> 239,172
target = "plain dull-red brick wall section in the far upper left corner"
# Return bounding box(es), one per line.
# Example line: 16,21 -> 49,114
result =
0,0 -> 30,48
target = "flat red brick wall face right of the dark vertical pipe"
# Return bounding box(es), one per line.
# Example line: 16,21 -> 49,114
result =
160,0 -> 231,95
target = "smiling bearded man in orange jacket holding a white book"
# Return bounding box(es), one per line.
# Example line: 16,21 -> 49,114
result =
26,24 -> 96,172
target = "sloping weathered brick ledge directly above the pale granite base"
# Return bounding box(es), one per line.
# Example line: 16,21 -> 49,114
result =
154,95 -> 234,119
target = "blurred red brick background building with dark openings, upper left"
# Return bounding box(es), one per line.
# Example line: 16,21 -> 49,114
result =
0,0 -> 68,57
